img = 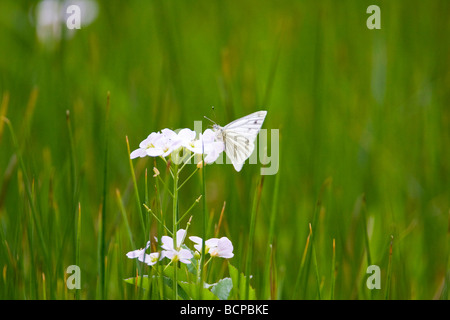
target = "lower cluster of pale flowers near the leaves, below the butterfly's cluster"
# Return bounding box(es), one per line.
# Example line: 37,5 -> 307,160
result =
126,229 -> 234,266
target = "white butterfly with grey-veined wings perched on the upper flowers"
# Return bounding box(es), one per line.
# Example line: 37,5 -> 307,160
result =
213,110 -> 267,171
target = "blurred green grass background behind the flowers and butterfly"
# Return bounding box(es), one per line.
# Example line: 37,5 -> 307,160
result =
0,0 -> 450,299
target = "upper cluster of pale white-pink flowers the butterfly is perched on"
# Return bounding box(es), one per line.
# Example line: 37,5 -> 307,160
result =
130,128 -> 225,164
